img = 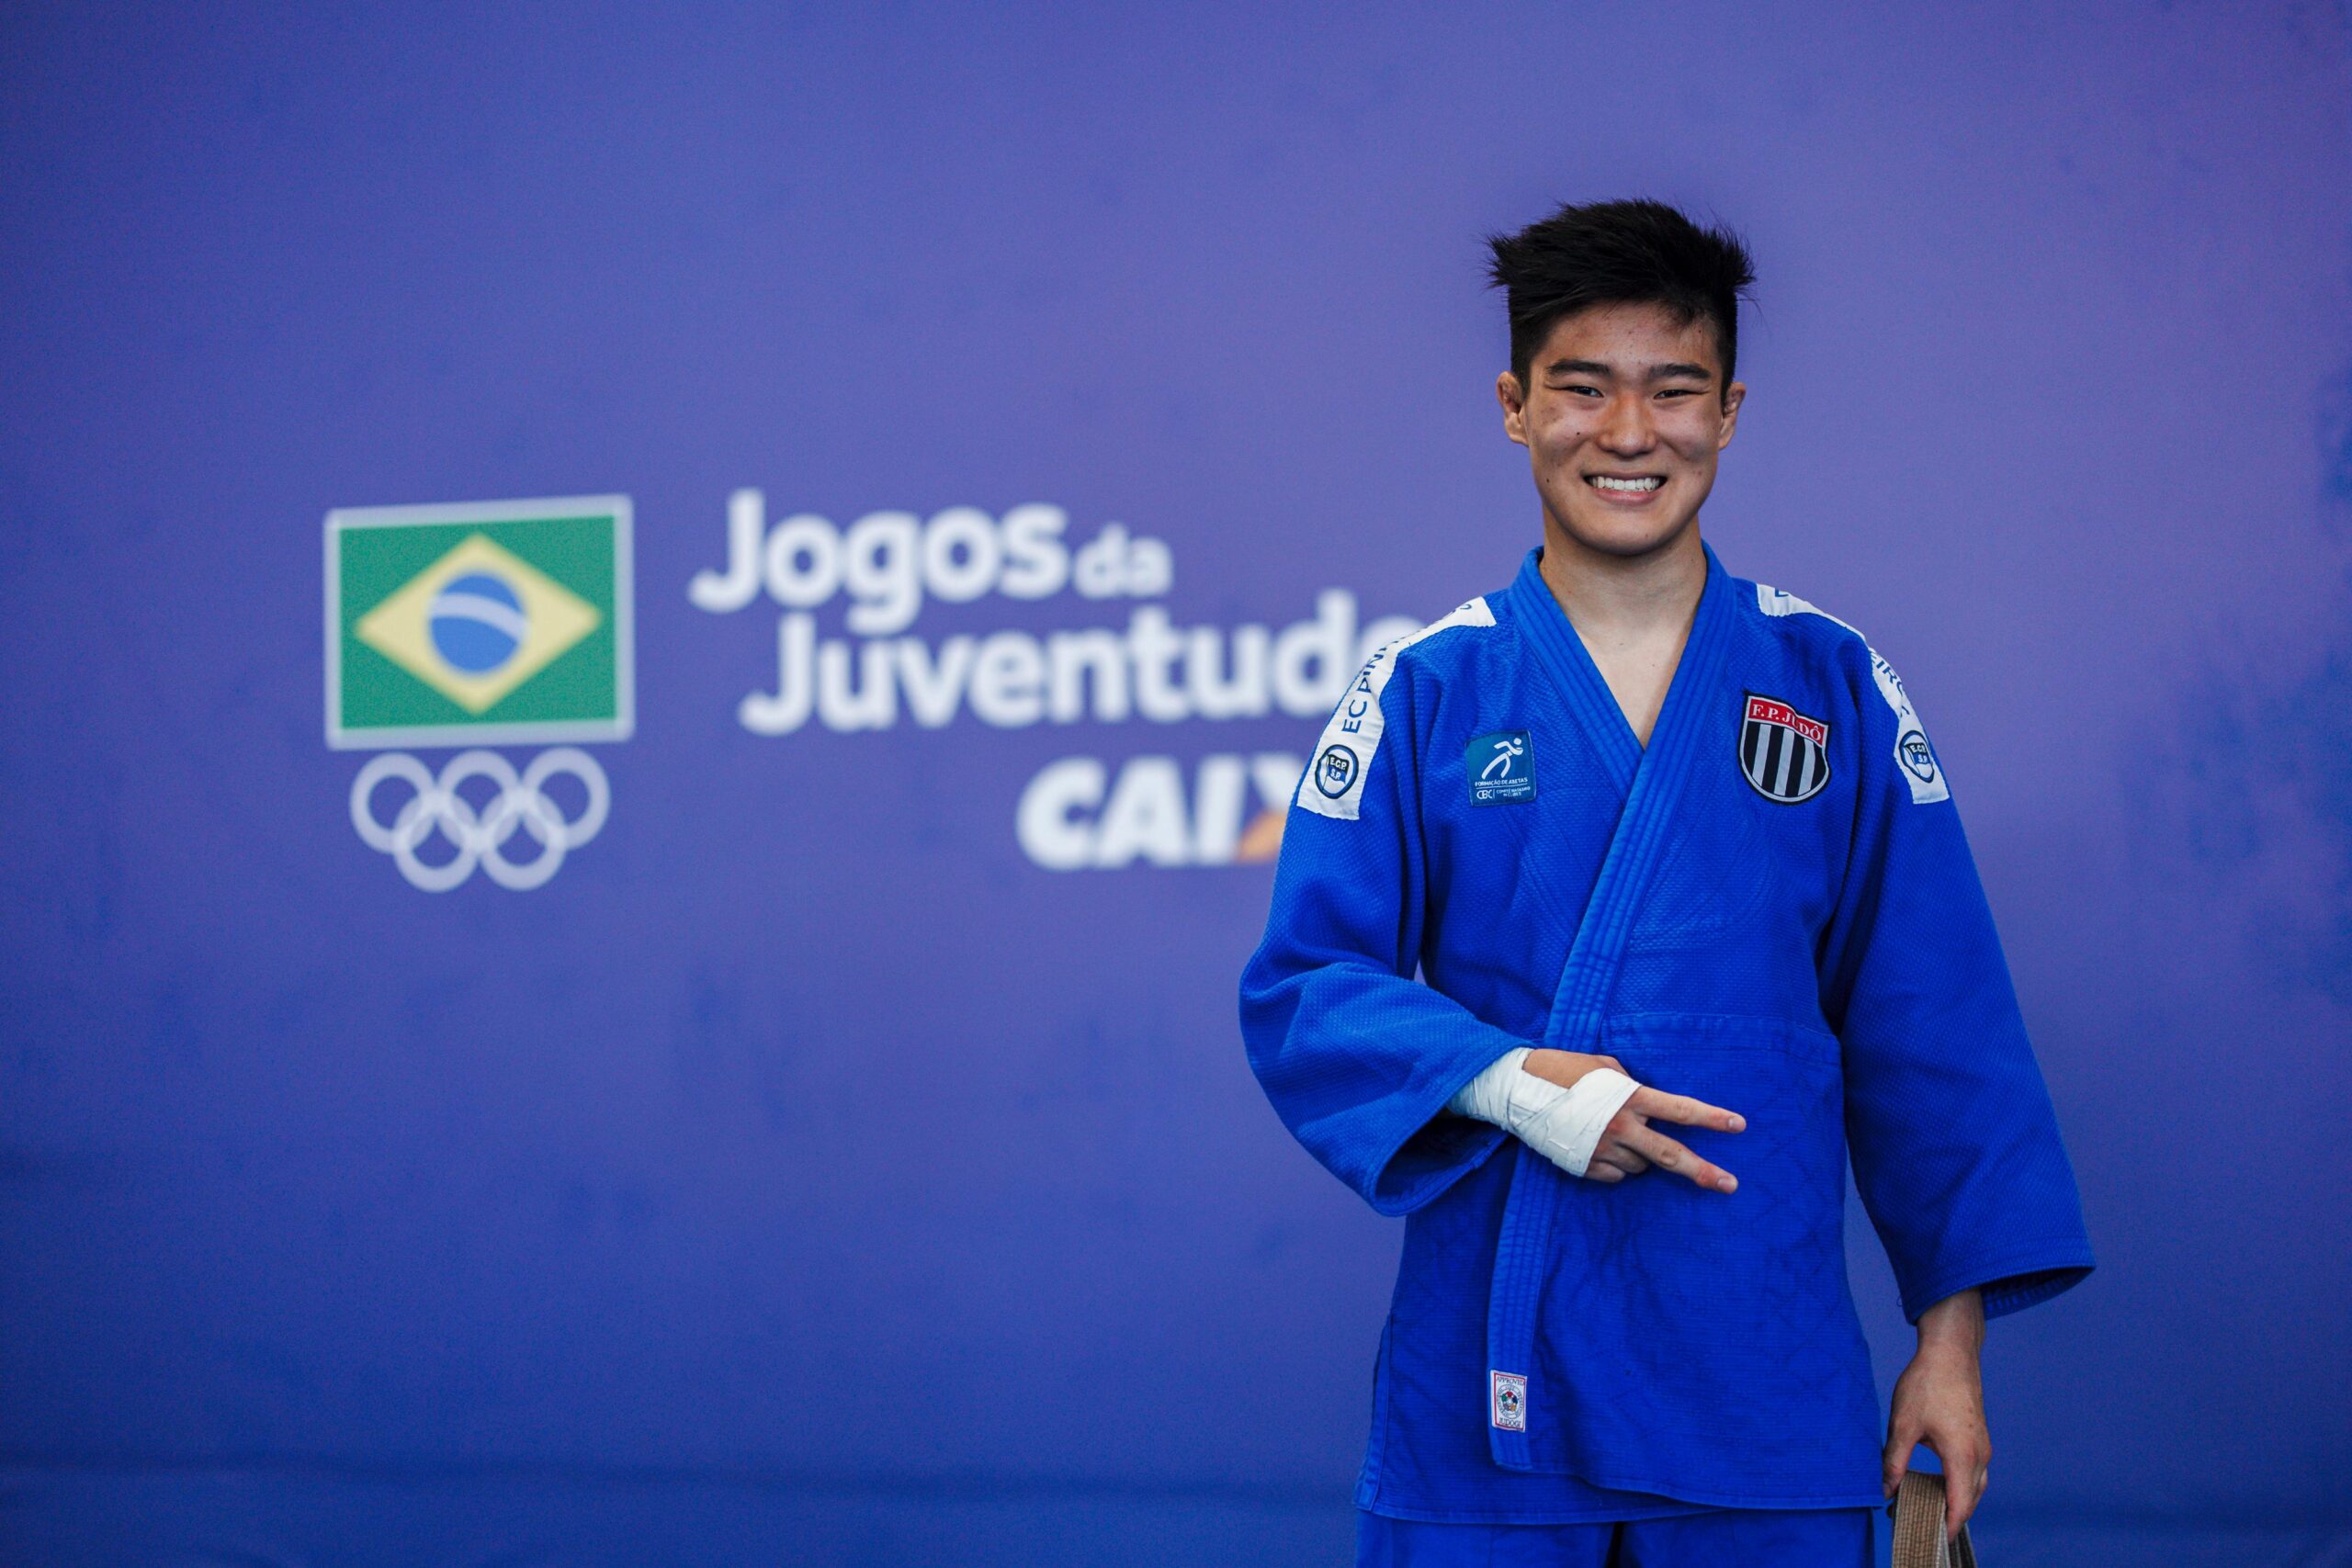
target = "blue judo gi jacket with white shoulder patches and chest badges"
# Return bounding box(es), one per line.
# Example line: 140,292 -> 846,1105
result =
1242,550 -> 2091,1523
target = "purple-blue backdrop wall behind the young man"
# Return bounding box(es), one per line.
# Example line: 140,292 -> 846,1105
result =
0,5 -> 2352,1568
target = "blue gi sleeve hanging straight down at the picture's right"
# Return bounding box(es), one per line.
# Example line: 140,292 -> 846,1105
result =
1823,644 -> 2093,1321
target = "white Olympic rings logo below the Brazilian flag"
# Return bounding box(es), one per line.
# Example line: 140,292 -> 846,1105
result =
350,745 -> 612,894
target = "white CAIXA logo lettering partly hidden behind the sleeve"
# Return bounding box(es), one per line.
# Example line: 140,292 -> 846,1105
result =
1013,752 -> 1301,872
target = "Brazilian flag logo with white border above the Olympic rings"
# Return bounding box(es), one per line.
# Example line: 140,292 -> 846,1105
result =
327,496 -> 635,750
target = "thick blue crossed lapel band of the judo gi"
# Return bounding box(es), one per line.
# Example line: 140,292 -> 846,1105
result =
1487,546 -> 1736,1470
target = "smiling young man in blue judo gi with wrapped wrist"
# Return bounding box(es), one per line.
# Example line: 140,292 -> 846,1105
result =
1242,202 -> 2091,1568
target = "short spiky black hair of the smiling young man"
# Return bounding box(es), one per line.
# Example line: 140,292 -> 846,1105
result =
1487,200 -> 1757,398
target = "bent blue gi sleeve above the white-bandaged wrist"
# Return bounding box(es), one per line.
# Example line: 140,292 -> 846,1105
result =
1242,660 -> 1533,1215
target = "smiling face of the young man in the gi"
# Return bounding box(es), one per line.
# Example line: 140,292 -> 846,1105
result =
1496,303 -> 1747,558
